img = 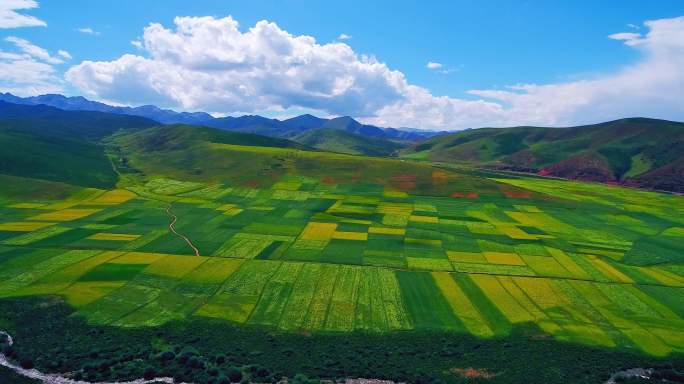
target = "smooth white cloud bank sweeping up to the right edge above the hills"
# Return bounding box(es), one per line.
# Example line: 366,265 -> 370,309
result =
369,17 -> 684,128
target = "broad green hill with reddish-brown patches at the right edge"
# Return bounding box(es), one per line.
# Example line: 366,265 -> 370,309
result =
403,118 -> 684,191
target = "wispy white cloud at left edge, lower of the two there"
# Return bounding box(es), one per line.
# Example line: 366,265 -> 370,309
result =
0,36 -> 71,96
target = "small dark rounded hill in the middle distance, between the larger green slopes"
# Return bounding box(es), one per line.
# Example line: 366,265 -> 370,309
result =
293,128 -> 405,156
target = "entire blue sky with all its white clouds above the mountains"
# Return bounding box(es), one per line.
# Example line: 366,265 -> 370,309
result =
0,0 -> 684,130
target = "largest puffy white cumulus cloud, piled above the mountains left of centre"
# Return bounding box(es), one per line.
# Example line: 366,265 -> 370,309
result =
66,17 -> 406,116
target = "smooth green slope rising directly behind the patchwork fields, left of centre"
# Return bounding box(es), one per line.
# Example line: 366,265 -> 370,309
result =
108,126 -> 496,194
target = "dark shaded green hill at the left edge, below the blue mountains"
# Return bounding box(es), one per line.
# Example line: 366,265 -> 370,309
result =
0,102 -> 158,188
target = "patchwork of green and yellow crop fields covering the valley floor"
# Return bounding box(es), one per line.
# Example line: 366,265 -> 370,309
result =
0,170 -> 684,356
